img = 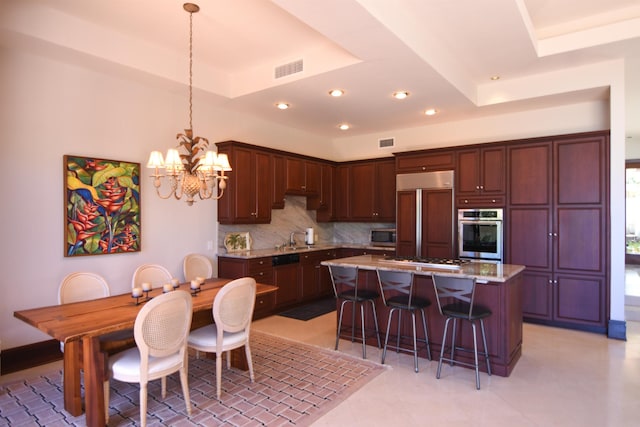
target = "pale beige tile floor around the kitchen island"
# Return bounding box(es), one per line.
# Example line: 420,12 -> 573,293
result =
2,312 -> 640,427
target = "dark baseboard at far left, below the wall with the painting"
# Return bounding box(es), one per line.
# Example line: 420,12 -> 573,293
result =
0,340 -> 62,375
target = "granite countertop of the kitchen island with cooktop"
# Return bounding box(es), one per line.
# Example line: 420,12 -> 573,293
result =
321,255 -> 525,283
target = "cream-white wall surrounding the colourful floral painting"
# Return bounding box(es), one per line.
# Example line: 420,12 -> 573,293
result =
0,47 -> 328,348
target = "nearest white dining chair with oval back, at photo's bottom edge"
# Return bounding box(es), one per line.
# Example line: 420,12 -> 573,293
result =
104,290 -> 192,427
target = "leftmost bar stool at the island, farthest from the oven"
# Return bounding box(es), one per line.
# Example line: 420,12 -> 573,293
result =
329,265 -> 380,359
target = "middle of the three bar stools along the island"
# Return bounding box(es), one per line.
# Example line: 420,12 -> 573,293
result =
378,270 -> 431,372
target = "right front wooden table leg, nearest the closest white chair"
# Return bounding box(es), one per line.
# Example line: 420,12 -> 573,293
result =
82,336 -> 106,427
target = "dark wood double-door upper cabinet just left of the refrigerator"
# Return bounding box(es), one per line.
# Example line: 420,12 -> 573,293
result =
349,159 -> 396,222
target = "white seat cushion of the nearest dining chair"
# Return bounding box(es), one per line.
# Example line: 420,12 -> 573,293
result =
109,347 -> 183,383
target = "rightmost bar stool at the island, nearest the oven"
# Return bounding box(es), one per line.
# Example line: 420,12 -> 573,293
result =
432,274 -> 491,390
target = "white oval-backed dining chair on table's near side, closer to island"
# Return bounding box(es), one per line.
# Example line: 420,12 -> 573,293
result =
188,277 -> 256,399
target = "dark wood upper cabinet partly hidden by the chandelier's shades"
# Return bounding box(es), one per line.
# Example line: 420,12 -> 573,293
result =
216,141 -> 273,224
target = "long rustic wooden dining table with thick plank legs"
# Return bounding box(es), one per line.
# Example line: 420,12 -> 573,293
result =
14,278 -> 278,426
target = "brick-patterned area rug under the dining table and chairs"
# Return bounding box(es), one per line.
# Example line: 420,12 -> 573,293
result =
0,331 -> 385,427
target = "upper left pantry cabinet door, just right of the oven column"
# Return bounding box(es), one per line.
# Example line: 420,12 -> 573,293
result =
508,143 -> 552,205
